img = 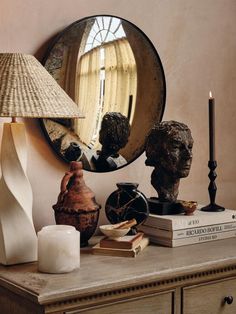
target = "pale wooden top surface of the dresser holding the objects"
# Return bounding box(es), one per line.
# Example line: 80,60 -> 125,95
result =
0,238 -> 236,304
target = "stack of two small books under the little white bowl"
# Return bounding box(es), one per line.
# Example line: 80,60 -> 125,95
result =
92,232 -> 149,257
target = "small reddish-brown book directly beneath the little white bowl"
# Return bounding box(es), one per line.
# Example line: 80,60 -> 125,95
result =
100,232 -> 143,249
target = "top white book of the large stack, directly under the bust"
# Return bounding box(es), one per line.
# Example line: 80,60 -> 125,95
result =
144,209 -> 236,230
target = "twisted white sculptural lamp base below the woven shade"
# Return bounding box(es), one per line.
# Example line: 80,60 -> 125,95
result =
0,123 -> 37,265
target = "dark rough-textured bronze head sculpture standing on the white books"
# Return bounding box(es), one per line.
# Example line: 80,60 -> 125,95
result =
145,121 -> 193,215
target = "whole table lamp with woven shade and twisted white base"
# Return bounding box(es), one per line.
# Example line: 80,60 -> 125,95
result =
0,53 -> 81,265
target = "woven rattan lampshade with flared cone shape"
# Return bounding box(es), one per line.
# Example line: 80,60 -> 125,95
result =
0,53 -> 82,118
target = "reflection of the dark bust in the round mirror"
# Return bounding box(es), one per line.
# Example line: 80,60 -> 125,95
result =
92,112 -> 130,171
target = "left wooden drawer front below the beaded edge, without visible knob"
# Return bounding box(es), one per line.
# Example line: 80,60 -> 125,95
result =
65,291 -> 174,314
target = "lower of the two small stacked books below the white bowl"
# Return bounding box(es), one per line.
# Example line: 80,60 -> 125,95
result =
92,237 -> 149,257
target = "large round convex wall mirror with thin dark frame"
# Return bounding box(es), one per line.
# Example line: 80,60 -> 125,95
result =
41,15 -> 166,172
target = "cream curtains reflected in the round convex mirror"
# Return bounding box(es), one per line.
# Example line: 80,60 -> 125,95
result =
74,38 -> 137,149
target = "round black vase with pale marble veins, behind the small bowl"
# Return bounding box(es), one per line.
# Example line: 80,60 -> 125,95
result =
105,182 -> 149,225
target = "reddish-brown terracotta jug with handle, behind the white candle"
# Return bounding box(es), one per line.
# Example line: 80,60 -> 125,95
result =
53,161 -> 101,247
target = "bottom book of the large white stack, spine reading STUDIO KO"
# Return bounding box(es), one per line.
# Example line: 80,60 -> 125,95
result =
149,230 -> 236,247
